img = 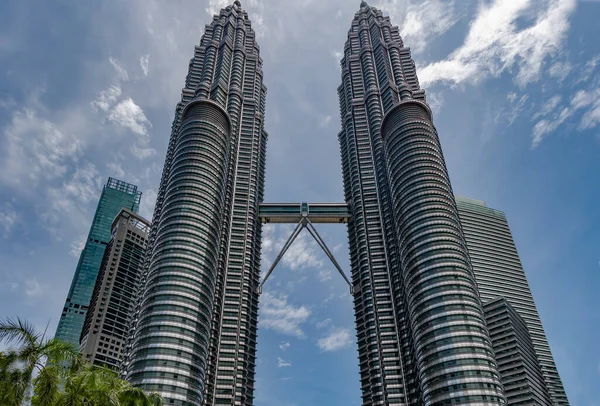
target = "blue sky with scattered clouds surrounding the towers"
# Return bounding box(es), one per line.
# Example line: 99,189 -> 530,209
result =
0,0 -> 600,406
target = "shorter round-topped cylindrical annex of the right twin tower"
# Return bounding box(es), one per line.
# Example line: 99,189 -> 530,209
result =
382,99 -> 504,405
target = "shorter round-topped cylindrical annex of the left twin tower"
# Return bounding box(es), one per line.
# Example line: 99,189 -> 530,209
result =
129,100 -> 230,402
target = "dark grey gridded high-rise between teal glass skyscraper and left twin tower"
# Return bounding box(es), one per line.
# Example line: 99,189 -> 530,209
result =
79,209 -> 150,370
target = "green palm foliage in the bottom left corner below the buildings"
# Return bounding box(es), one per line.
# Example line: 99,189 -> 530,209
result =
0,318 -> 163,406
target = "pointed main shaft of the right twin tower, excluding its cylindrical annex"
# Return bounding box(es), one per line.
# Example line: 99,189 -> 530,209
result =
338,2 -> 416,405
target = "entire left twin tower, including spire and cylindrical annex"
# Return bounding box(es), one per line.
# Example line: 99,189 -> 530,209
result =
124,1 -> 267,406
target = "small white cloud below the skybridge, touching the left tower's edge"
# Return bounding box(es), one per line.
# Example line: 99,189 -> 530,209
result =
259,293 -> 310,338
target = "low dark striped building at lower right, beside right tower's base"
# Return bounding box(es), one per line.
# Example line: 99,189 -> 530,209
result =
483,297 -> 552,406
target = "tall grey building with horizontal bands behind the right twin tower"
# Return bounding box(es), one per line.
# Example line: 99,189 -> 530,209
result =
456,197 -> 569,406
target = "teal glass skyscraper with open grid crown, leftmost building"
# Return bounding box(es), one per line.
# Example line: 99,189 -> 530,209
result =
55,178 -> 142,347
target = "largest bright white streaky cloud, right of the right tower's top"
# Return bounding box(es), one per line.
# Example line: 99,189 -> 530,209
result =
419,0 -> 576,87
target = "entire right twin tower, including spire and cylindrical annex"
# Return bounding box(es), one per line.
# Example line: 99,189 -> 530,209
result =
338,2 -> 505,406
